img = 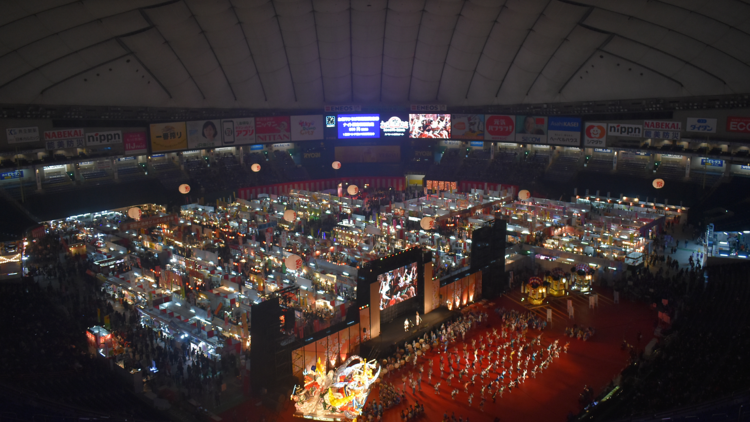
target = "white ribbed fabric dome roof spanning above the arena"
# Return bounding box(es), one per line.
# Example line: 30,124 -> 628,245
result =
0,0 -> 750,109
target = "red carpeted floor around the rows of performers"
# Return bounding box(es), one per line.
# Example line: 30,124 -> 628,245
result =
221,290 -> 656,422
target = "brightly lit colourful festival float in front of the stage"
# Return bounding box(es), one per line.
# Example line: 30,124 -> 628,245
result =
291,355 -> 380,421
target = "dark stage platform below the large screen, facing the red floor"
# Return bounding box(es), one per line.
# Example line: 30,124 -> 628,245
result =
360,306 -> 461,359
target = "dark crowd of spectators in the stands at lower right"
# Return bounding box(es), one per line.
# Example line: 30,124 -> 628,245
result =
622,264 -> 750,416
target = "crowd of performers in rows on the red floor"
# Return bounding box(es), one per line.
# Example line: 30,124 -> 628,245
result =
365,307 -> 569,422
